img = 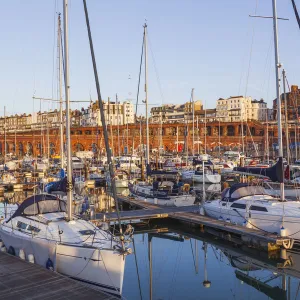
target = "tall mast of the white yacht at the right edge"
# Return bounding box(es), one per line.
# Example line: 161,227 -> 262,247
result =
272,0 -> 284,201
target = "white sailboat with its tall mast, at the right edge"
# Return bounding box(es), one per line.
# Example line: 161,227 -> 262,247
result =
203,0 -> 300,240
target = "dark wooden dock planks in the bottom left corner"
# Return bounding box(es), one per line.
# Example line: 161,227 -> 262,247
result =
0,252 -> 117,300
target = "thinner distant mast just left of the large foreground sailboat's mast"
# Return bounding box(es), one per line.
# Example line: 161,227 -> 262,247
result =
57,14 -> 64,169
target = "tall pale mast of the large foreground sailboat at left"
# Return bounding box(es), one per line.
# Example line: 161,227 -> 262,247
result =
64,0 -> 73,221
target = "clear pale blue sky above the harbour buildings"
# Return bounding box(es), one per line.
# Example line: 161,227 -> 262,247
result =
0,0 -> 300,115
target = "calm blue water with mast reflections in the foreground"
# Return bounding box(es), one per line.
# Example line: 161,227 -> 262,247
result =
123,225 -> 300,300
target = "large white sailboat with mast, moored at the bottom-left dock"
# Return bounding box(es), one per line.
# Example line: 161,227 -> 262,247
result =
0,0 -> 127,296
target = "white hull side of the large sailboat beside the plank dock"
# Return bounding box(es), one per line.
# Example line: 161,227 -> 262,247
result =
0,229 -> 125,295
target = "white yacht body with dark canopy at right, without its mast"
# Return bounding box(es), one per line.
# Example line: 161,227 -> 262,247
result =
204,183 -> 300,240
